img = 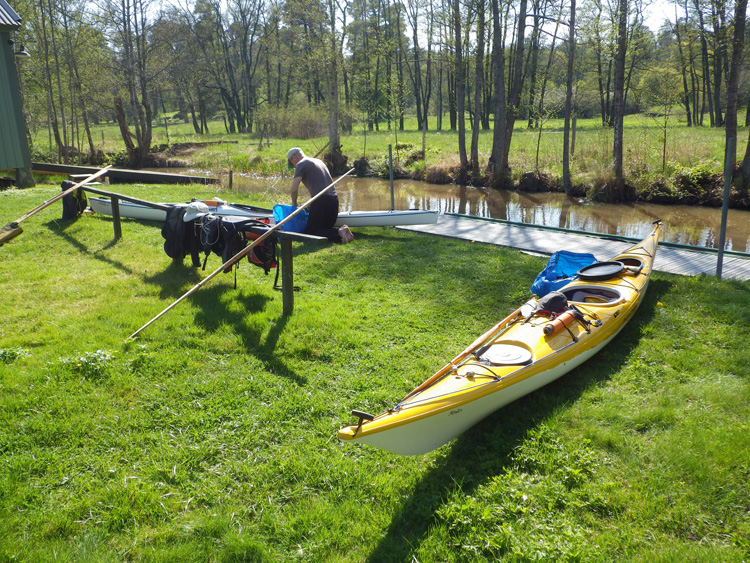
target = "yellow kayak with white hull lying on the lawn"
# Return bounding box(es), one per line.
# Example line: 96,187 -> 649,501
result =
338,221 -> 661,455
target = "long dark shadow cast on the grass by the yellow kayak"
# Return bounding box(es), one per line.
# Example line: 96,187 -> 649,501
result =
367,279 -> 673,563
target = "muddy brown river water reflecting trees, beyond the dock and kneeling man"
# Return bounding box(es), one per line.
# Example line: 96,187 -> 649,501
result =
170,170 -> 750,252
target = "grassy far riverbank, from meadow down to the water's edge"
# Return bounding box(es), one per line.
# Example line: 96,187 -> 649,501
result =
25,114 -> 750,209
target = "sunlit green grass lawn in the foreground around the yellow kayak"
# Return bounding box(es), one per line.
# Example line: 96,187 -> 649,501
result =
0,186 -> 750,563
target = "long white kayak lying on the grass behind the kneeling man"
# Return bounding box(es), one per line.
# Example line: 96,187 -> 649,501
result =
88,197 -> 438,227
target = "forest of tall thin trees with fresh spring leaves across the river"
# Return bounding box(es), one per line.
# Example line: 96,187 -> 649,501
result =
14,0 -> 750,203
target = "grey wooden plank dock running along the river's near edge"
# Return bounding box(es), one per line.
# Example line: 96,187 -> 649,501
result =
398,214 -> 750,280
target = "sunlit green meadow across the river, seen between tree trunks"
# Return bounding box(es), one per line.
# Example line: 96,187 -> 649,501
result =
33,111 -> 747,192
